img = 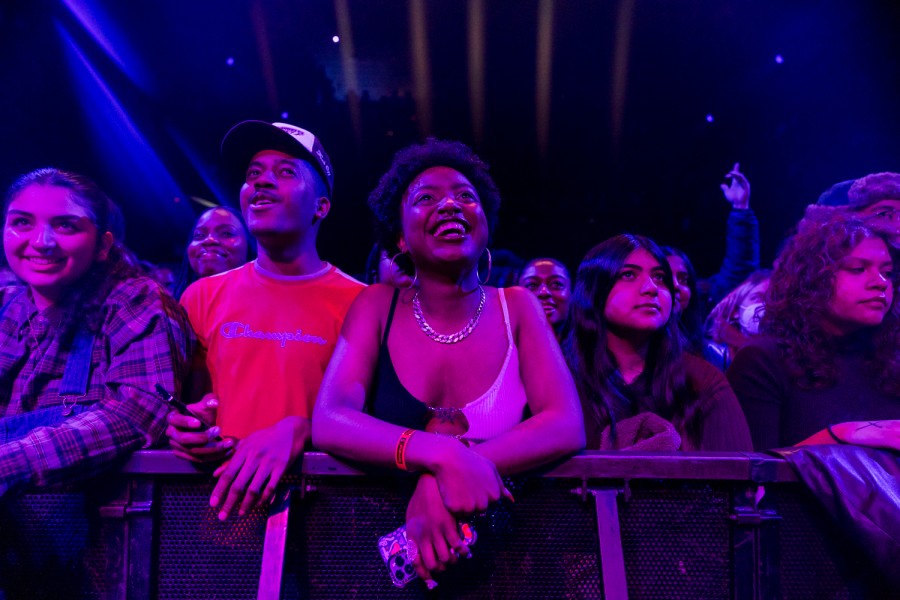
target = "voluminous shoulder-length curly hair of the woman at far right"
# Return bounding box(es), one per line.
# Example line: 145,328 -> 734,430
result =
760,206 -> 900,394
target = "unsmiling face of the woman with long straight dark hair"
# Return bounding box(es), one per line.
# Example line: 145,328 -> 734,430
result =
603,248 -> 672,340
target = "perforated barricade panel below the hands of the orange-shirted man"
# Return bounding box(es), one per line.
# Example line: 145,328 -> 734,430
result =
156,478 -> 266,600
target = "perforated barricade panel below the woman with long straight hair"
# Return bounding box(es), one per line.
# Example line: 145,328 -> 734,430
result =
619,481 -> 732,600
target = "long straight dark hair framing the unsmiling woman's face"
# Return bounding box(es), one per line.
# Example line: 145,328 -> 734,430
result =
563,234 -> 701,447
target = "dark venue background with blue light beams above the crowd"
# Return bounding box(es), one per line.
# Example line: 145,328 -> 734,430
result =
0,0 -> 900,274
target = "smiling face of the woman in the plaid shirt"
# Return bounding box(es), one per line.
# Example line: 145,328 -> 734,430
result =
3,184 -> 113,309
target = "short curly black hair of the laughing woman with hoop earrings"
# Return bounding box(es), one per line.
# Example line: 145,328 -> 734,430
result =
369,138 -> 500,255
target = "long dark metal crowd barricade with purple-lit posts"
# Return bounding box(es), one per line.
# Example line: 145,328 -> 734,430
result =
0,451 -> 891,600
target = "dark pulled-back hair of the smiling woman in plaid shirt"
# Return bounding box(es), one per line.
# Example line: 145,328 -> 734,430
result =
3,167 -> 141,341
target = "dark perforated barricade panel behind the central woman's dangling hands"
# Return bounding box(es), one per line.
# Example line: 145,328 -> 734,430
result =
285,479 -> 601,599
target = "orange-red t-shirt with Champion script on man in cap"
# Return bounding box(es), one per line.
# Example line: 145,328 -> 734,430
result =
181,261 -> 364,438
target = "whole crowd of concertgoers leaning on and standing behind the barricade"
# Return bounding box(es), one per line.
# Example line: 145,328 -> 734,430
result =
0,121 -> 900,581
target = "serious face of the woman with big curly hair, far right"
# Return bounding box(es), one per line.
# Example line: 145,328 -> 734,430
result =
825,238 -> 894,335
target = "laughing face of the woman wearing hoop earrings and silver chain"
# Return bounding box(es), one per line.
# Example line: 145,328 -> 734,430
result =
398,167 -> 488,268
